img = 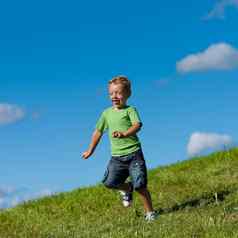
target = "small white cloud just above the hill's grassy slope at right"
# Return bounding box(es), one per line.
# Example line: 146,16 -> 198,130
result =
187,132 -> 232,156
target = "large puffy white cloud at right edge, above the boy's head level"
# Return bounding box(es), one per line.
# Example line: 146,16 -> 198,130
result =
176,43 -> 238,73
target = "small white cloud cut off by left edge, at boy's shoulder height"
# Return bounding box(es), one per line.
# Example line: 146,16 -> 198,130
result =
0,103 -> 25,125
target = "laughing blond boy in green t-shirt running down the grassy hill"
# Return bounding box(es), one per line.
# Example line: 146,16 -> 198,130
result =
82,76 -> 157,221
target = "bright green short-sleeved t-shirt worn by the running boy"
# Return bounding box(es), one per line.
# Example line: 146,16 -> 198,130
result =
96,106 -> 141,156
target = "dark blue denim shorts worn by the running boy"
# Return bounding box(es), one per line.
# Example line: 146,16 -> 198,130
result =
102,149 -> 147,190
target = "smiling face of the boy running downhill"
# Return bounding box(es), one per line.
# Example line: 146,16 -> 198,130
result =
109,83 -> 128,108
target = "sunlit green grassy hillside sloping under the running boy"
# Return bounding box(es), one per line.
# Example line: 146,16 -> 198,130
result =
0,148 -> 238,238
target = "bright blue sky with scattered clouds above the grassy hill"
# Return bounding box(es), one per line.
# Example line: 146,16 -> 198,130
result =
0,0 -> 238,207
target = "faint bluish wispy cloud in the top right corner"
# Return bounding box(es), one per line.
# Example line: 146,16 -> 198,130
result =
204,0 -> 238,20
